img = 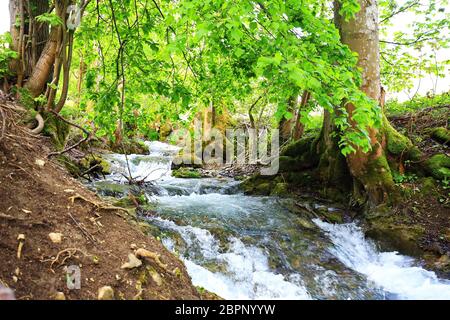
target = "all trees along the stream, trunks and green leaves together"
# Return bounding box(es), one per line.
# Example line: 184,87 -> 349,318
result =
0,0 -> 448,208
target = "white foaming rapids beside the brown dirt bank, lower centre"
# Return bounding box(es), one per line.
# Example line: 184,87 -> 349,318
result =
154,218 -> 310,299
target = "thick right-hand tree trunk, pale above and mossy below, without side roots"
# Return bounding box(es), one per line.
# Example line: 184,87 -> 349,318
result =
335,0 -> 394,205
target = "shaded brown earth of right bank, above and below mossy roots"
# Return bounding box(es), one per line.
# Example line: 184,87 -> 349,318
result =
368,104 -> 450,277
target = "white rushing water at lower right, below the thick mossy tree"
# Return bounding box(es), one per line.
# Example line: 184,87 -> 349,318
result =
314,219 -> 450,300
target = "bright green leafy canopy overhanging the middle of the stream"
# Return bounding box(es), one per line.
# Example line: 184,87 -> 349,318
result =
65,0 -> 381,154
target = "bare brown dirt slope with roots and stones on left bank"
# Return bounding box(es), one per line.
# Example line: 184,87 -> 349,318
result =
0,102 -> 201,299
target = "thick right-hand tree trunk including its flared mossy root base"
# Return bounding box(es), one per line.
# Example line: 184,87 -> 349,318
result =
317,0 -> 417,207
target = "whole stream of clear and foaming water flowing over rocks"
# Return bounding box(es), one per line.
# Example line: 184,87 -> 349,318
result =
89,142 -> 450,299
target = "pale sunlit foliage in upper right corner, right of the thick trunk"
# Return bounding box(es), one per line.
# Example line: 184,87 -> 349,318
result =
379,0 -> 450,92
